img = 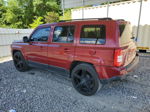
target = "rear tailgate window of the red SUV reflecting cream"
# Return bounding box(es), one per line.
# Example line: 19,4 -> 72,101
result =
119,23 -> 132,46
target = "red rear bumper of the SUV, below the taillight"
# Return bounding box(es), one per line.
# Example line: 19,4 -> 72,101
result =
96,54 -> 139,79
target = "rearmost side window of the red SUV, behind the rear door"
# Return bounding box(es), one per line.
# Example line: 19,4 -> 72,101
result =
80,25 -> 106,44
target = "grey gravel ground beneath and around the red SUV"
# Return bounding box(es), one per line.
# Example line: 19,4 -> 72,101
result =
0,55 -> 150,112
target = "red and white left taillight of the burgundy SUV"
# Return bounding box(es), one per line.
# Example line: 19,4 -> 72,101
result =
114,49 -> 123,67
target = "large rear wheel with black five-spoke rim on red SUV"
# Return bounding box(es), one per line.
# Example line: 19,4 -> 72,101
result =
71,63 -> 102,96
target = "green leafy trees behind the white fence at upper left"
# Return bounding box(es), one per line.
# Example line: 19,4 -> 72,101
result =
0,0 -> 61,28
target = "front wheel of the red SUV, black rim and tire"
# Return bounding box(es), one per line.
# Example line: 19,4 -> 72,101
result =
13,51 -> 29,72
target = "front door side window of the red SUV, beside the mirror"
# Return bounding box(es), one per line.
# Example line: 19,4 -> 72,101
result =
30,28 -> 50,42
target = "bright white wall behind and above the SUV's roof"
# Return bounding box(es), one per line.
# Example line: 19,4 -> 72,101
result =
72,0 -> 150,25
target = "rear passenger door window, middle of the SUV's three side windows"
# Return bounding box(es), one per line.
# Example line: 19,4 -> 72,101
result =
53,26 -> 75,43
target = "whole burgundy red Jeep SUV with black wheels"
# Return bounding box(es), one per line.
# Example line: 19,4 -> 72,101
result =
11,18 -> 139,96
